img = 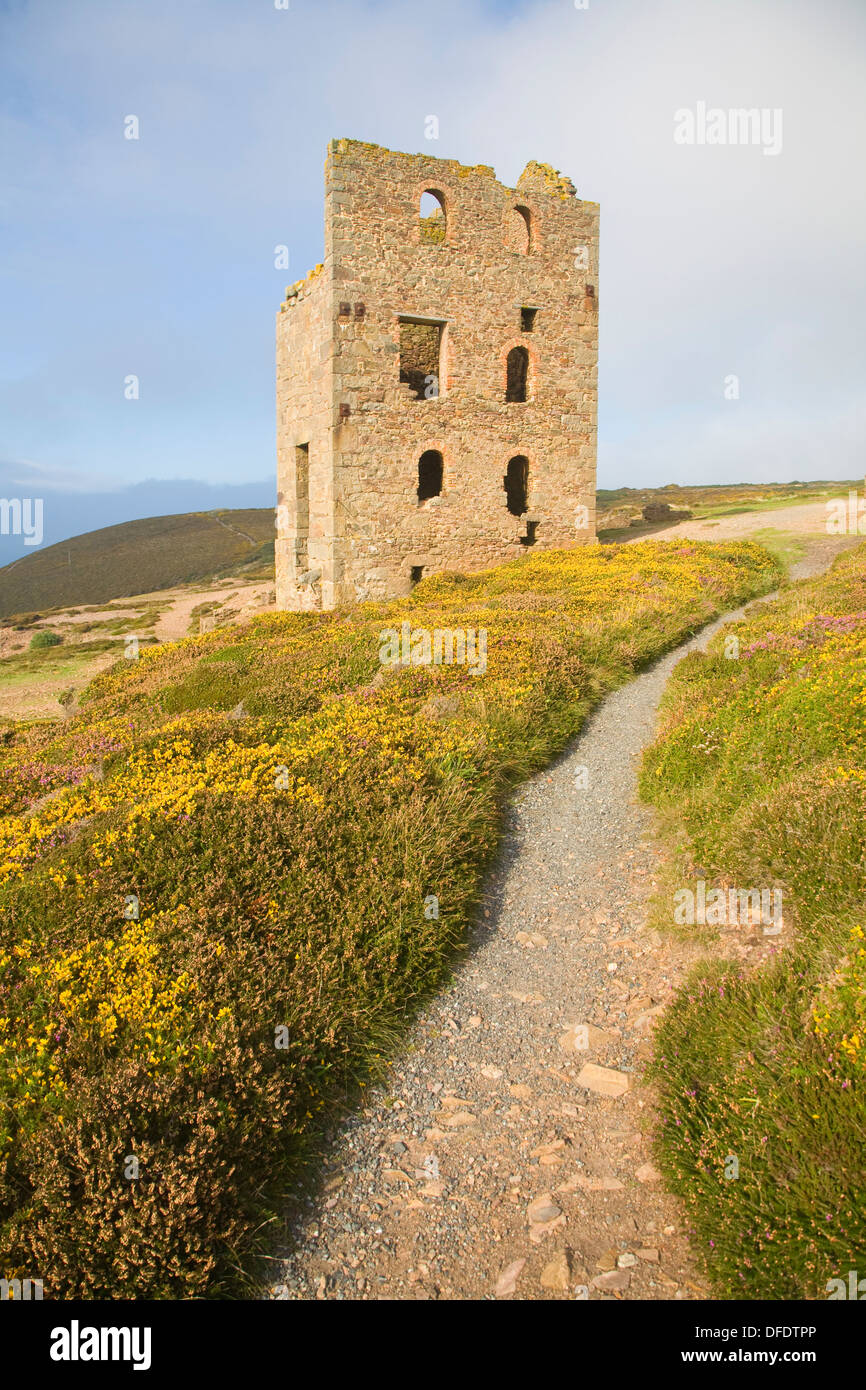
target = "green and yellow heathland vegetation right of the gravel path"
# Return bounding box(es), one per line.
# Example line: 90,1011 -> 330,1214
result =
642,546 -> 866,1298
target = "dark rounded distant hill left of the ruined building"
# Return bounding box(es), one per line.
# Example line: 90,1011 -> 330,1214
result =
0,507 -> 274,617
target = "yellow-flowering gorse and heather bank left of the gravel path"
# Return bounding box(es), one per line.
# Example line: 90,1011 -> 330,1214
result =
0,543 -> 778,1298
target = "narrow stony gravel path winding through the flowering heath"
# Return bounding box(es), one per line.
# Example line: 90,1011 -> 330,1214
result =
265,536 -> 850,1300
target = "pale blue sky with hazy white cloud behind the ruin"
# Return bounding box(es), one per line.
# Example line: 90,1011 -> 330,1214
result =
0,0 -> 866,545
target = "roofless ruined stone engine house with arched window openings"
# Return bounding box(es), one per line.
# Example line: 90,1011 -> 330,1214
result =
277,140 -> 599,609
